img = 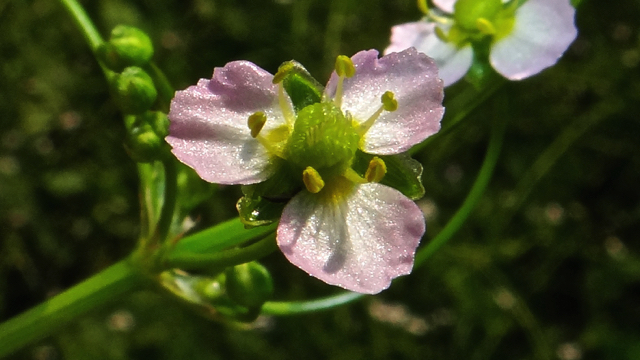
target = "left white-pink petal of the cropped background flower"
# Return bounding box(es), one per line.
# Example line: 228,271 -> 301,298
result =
384,21 -> 473,87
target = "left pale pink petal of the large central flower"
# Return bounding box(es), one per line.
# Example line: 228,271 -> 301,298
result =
166,61 -> 284,184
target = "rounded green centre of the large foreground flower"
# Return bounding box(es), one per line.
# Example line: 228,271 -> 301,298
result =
287,102 -> 360,170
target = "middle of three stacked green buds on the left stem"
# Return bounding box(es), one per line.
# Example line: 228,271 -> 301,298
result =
113,66 -> 158,114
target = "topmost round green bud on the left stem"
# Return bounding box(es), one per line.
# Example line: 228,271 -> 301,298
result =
98,25 -> 153,72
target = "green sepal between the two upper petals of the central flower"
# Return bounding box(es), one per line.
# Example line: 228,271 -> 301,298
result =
273,60 -> 324,113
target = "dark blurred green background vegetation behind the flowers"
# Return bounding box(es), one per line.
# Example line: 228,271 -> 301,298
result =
0,0 -> 640,360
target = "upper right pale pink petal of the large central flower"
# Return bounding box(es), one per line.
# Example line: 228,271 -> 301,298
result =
325,48 -> 444,155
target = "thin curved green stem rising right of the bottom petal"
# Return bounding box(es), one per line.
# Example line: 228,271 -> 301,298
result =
415,94 -> 506,267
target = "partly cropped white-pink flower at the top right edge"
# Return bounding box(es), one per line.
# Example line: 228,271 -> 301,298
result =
385,0 -> 577,86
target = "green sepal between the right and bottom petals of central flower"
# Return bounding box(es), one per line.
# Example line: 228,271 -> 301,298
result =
352,150 -> 425,200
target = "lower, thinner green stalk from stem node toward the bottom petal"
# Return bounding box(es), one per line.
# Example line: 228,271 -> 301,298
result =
164,233 -> 277,270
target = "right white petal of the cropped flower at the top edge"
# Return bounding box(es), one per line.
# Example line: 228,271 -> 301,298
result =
490,0 -> 578,80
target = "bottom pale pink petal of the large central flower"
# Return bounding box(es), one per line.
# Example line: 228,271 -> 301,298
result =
277,183 -> 425,294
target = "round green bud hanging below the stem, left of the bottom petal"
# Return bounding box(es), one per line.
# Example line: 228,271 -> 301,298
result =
225,261 -> 273,308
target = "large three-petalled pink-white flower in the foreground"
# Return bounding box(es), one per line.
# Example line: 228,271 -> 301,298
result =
166,48 -> 444,293
